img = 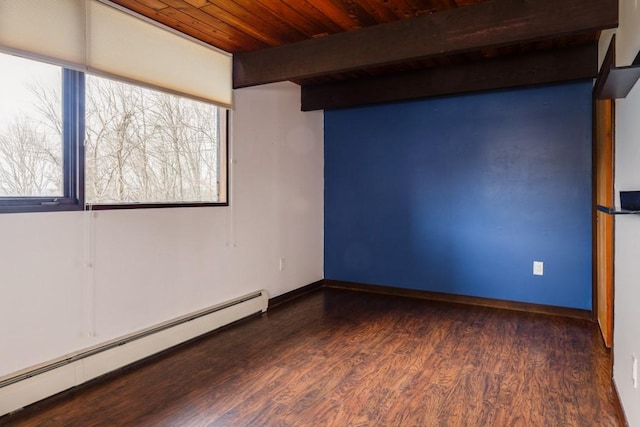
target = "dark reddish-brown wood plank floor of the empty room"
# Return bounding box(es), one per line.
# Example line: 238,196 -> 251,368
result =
0,289 -> 622,426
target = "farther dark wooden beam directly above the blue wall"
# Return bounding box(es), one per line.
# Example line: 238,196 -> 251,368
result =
302,43 -> 598,111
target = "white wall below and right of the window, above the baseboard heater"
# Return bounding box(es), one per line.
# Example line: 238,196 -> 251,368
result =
0,83 -> 324,377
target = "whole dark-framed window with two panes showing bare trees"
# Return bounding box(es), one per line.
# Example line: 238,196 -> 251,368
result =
0,53 -> 227,212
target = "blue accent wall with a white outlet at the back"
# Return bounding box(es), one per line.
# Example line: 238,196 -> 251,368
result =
325,82 -> 592,309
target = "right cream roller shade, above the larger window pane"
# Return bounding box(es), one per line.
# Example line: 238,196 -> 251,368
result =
87,1 -> 232,106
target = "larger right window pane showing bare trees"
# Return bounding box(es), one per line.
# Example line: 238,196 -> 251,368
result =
85,75 -> 223,204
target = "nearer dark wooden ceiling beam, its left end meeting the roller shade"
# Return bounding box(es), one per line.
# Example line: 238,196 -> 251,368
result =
233,0 -> 618,88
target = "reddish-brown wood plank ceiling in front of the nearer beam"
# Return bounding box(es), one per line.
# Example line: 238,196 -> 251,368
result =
113,0 -> 486,53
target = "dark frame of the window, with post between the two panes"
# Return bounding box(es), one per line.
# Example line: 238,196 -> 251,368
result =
0,62 -> 230,213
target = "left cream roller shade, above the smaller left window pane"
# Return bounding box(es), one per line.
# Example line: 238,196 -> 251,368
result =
0,0 -> 86,69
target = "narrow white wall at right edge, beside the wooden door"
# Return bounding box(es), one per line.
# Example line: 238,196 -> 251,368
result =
607,0 -> 640,426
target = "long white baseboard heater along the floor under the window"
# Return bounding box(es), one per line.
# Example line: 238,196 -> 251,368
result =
0,291 -> 269,416
